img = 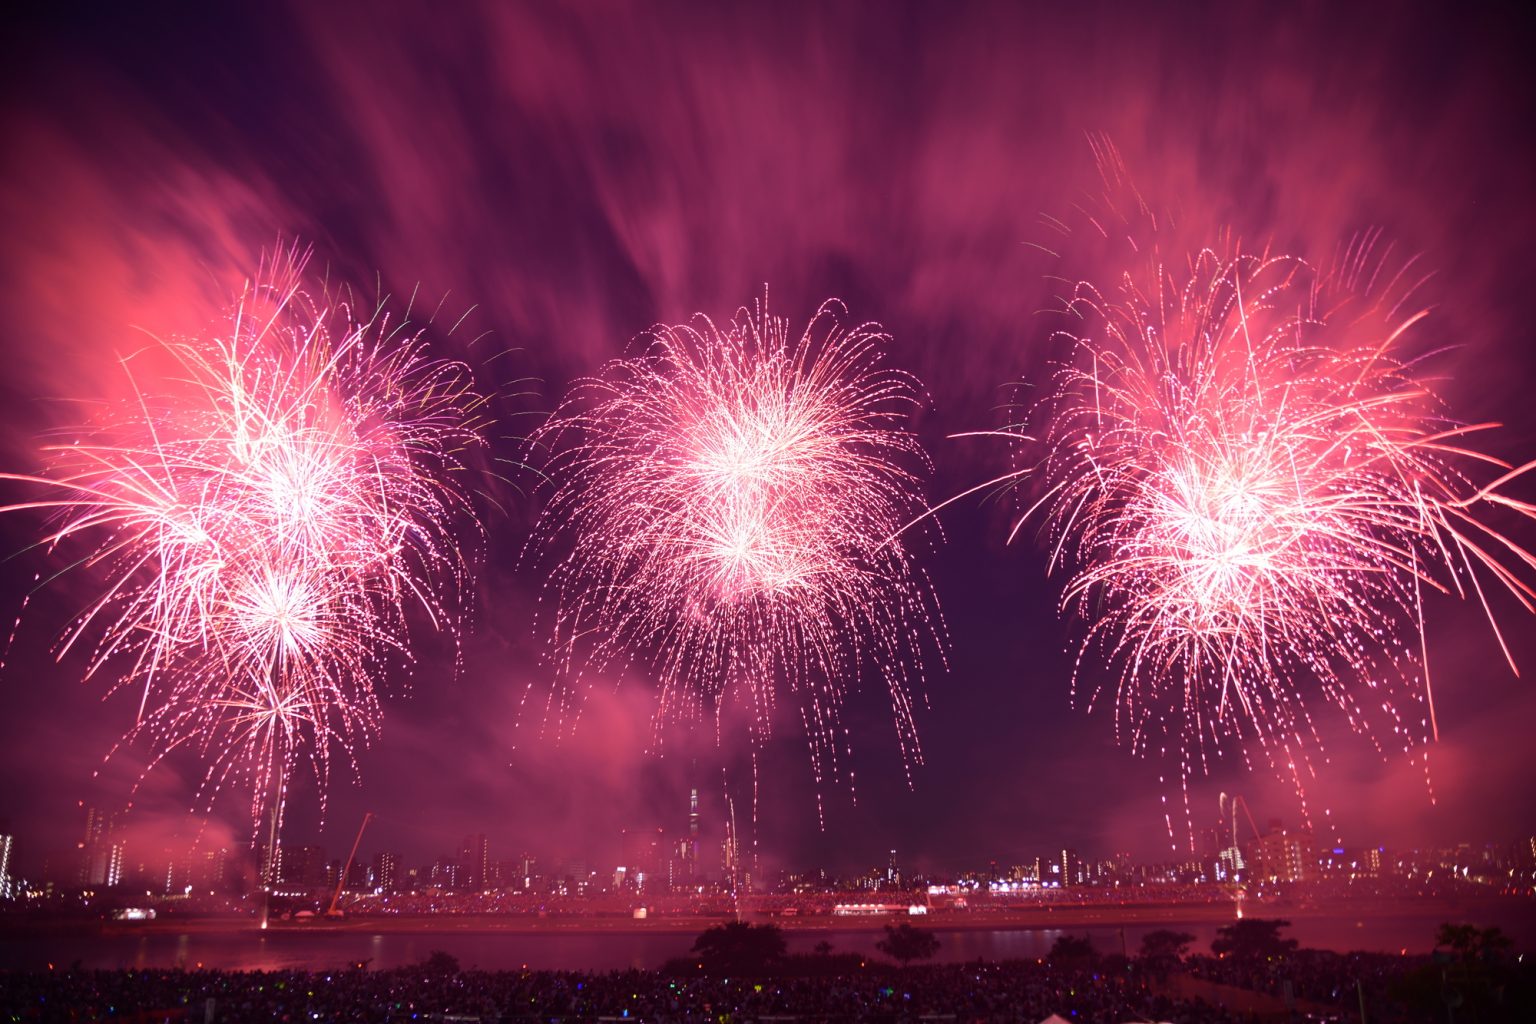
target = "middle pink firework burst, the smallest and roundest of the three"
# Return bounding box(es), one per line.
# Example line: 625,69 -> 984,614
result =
535,302 -> 943,798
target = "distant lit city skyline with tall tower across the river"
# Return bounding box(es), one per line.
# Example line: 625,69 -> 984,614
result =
0,800 -> 1536,898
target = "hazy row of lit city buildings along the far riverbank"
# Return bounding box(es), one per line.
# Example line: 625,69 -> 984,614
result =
0,792 -> 1536,900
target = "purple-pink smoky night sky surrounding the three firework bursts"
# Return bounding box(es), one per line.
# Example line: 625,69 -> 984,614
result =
0,3 -> 1536,869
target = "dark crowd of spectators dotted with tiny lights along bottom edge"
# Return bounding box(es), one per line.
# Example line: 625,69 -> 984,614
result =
0,961 -> 1370,1024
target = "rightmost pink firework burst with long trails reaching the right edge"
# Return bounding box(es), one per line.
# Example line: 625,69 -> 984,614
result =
1015,237 -> 1536,816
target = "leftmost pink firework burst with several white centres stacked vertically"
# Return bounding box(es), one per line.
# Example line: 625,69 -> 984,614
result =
6,249 -> 482,835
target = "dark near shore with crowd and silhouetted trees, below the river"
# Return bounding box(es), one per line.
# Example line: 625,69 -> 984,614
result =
12,918 -> 1536,1024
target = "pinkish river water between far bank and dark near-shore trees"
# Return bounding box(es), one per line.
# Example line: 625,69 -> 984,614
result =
0,904 -> 1536,970
